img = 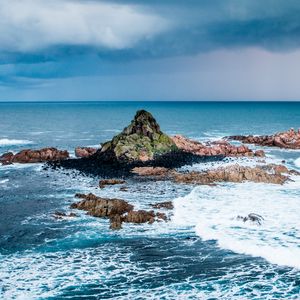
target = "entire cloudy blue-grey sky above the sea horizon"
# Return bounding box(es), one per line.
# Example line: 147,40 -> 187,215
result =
0,0 -> 300,101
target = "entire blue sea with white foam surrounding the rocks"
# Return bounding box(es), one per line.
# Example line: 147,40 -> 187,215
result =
0,102 -> 300,299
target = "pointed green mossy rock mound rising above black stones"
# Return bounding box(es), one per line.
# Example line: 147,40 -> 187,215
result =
99,110 -> 177,162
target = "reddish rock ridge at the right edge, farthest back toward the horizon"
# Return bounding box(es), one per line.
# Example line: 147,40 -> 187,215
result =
227,128 -> 300,149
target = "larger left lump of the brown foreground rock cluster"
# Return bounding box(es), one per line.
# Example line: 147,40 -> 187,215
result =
71,194 -> 133,217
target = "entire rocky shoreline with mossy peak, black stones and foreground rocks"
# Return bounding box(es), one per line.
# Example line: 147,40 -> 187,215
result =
0,110 -> 300,229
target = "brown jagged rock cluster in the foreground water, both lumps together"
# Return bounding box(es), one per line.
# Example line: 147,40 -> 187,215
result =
71,194 -> 167,229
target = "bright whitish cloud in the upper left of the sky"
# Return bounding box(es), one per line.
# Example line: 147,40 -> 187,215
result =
0,0 -> 170,52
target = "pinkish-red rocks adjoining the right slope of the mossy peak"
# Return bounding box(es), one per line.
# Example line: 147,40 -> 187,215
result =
172,135 -> 264,157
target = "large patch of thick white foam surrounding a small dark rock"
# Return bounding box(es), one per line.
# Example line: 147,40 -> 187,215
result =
173,178 -> 300,269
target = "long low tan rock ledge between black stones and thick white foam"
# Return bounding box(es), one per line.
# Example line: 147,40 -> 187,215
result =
131,164 -> 300,185
